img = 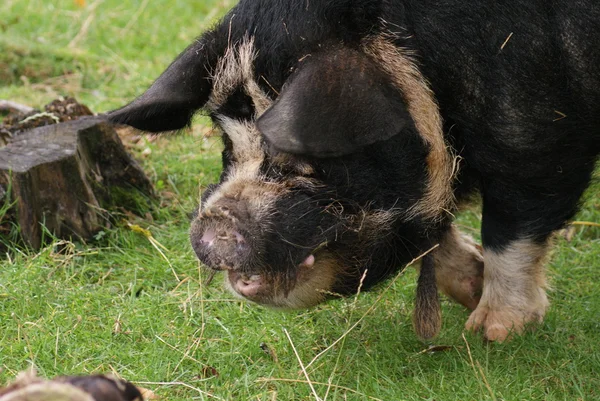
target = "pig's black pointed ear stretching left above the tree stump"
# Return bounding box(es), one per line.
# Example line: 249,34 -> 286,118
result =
108,43 -> 211,132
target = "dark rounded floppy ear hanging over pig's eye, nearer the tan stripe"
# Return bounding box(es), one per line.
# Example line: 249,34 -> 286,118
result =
257,49 -> 410,157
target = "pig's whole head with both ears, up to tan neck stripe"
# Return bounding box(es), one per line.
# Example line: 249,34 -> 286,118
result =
109,2 -> 451,308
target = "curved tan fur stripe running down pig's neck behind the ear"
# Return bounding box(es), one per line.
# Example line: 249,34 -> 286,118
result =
363,36 -> 455,219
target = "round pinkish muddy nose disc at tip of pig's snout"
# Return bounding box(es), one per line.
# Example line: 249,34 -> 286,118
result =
190,205 -> 256,270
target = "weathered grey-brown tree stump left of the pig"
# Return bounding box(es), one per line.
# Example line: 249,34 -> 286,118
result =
0,117 -> 153,248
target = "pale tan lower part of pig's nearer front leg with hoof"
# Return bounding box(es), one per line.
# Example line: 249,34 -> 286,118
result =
466,239 -> 548,341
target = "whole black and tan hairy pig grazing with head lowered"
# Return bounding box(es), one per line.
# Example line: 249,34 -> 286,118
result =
109,0 -> 600,341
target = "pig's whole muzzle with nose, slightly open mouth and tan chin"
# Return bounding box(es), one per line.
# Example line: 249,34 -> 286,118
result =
190,193 -> 346,309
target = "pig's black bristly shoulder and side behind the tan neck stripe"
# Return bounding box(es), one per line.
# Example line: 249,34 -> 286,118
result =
398,0 -> 600,250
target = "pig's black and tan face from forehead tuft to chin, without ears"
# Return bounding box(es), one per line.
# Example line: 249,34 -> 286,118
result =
180,40 -> 438,308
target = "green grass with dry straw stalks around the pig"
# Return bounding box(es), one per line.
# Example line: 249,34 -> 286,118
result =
0,0 -> 600,401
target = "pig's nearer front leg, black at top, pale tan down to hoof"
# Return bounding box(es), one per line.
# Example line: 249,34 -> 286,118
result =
466,180 -> 556,342
